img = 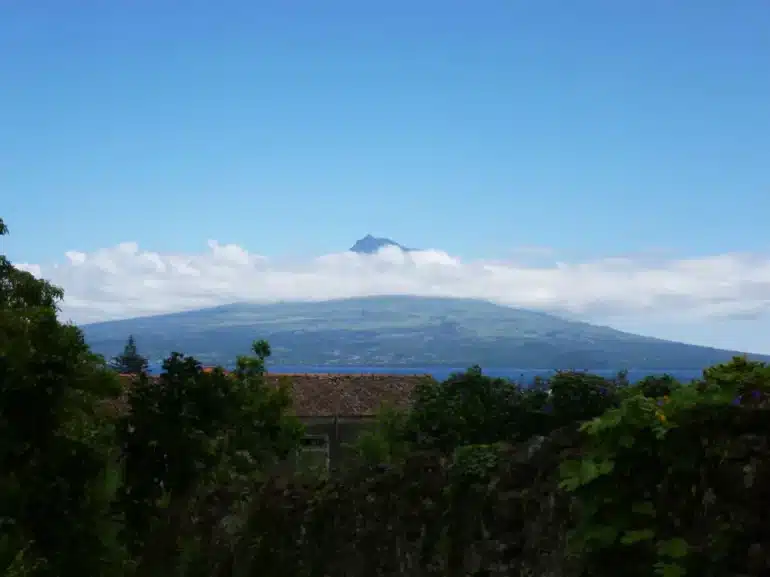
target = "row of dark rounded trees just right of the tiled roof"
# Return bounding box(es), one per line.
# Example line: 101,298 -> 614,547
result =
364,366 -> 625,462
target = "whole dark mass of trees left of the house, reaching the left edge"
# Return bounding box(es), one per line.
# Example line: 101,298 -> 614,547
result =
0,221 -> 302,577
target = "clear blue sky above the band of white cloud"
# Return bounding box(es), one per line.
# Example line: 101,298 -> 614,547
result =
0,0 -> 770,350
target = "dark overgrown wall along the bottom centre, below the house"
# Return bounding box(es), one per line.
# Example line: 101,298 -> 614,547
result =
226,442 -> 569,577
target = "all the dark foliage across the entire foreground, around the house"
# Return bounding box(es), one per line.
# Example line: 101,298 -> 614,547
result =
0,221 -> 770,577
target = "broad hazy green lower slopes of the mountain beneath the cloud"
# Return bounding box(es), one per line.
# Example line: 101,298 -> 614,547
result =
76,296 -> 770,370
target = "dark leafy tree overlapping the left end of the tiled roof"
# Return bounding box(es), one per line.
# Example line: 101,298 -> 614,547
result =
118,341 -> 302,574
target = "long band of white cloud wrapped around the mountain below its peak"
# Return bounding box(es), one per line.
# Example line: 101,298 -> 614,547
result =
13,241 -> 770,350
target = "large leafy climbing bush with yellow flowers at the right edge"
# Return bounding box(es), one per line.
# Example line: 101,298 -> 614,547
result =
561,358 -> 770,577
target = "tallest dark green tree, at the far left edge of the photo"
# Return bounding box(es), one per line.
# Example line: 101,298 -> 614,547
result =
0,220 -> 118,576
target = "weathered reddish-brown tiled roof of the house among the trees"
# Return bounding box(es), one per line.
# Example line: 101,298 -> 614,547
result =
112,369 -> 431,417
